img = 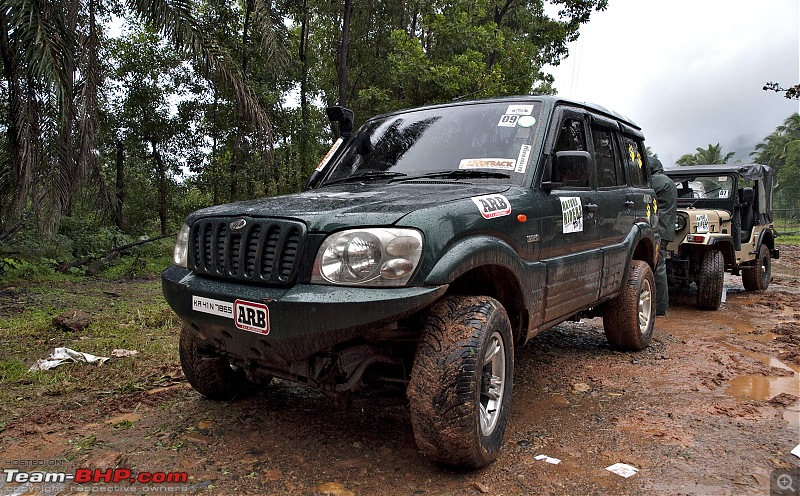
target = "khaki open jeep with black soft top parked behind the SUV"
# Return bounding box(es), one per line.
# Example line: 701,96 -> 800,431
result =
665,164 -> 779,310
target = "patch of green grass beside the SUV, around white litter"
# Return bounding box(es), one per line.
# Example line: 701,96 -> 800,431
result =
0,276 -> 180,422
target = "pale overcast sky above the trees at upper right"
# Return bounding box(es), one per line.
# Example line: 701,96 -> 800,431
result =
551,0 -> 800,164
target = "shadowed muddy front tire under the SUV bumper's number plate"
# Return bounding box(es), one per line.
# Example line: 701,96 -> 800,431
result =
178,326 -> 257,401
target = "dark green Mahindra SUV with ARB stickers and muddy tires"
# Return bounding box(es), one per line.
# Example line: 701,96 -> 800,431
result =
163,97 -> 657,467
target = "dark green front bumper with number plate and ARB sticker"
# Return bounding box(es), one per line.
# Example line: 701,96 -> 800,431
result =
161,266 -> 447,367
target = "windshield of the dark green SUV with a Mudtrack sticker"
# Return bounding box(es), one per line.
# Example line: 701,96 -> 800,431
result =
321,101 -> 542,186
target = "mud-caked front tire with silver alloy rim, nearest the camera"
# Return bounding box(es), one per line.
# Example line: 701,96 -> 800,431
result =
407,296 -> 514,468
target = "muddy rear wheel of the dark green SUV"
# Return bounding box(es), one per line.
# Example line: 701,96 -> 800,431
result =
603,260 -> 656,351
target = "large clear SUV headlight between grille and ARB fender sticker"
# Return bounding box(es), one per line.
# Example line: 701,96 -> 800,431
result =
311,228 -> 422,287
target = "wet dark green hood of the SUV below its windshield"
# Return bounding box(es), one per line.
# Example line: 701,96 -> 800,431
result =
187,182 -> 509,232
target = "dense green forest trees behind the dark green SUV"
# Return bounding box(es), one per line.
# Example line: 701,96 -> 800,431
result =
0,0 -> 607,272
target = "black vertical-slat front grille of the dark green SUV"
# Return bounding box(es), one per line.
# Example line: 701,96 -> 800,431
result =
189,217 -> 306,285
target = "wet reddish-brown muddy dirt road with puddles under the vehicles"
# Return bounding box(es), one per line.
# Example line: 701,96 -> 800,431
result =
0,247 -> 800,495
